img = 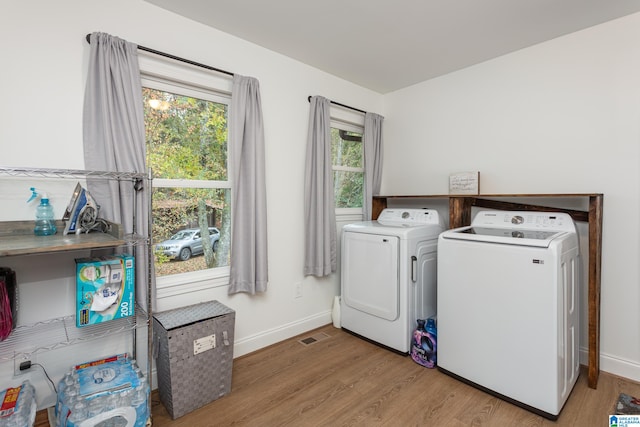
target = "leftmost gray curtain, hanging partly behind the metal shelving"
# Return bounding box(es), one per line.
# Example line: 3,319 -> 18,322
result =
83,33 -> 151,307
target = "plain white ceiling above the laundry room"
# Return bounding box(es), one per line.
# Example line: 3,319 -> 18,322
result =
146,0 -> 640,93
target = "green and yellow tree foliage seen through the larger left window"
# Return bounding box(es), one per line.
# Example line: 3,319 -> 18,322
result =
142,88 -> 229,267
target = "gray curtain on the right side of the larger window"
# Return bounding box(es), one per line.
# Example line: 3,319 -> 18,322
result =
229,74 -> 268,294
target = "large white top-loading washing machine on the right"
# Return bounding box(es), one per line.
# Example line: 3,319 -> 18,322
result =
438,211 -> 580,420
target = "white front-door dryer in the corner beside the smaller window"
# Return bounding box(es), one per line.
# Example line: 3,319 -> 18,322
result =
340,209 -> 444,353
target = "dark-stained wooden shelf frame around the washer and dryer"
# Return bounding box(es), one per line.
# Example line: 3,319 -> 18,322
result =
371,193 -> 604,389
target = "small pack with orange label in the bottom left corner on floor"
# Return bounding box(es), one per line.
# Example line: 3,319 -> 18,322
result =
0,380 -> 36,427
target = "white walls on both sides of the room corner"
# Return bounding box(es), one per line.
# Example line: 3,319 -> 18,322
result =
0,0 -> 640,406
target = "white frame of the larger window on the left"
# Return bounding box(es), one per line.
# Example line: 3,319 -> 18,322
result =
139,52 -> 233,297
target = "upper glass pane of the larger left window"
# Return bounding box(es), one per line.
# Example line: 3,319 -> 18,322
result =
142,88 -> 228,181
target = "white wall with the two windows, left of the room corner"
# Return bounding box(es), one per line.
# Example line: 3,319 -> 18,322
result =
0,0 -> 382,404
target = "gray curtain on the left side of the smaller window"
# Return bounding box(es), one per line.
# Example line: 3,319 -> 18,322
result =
304,96 -> 337,277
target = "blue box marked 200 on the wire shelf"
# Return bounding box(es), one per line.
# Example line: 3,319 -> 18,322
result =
76,254 -> 135,327
